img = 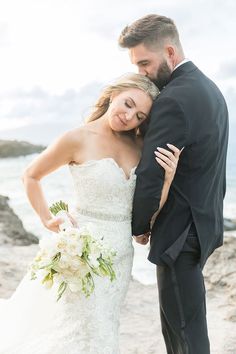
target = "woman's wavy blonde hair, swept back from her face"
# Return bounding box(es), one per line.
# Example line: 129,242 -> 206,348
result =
86,73 -> 159,134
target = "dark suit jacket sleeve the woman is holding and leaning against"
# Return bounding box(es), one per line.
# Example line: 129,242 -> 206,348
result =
132,96 -> 188,235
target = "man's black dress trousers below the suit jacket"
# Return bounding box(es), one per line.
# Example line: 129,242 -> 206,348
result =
157,228 -> 210,354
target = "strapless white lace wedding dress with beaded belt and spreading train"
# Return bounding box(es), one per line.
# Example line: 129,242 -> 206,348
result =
0,158 -> 136,354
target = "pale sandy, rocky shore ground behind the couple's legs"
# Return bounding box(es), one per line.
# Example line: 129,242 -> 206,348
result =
0,233 -> 236,354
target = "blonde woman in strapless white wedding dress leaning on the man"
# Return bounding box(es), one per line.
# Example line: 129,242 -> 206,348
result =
0,74 -> 179,354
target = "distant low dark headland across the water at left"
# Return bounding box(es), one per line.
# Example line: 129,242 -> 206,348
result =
0,140 -> 45,158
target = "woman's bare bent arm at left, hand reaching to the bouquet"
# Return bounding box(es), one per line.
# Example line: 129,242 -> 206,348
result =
22,130 -> 80,232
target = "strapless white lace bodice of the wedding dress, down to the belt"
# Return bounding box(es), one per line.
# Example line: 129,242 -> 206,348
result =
70,158 -> 136,221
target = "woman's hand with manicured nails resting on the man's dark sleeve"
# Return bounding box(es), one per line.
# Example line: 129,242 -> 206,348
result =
154,144 -> 184,184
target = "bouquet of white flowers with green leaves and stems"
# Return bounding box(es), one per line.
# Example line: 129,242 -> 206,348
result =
31,201 -> 116,301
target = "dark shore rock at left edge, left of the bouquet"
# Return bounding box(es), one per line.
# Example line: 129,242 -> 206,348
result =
0,196 -> 38,246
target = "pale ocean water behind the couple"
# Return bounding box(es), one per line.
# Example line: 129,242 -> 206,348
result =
0,144 -> 236,284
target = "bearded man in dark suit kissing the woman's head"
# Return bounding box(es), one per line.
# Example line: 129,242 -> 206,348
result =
119,15 -> 228,354
